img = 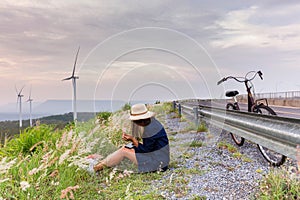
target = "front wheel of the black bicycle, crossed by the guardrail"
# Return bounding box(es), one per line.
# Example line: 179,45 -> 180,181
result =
252,104 -> 286,167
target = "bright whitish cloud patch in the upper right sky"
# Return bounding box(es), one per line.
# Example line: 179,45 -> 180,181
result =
207,4 -> 300,50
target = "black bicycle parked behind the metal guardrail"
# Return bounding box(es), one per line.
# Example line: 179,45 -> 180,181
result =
217,71 -> 286,166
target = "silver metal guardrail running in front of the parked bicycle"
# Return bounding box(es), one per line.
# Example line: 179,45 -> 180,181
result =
181,105 -> 300,160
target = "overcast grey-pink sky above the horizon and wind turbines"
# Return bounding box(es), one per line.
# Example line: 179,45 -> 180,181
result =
0,0 -> 300,105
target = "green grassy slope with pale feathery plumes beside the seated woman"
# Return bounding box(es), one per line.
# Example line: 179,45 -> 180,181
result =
0,103 -> 169,199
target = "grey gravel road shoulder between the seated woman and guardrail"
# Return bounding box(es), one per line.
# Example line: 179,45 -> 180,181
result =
153,115 -> 296,199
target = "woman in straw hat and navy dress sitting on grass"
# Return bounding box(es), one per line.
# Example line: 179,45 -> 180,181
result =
89,104 -> 170,172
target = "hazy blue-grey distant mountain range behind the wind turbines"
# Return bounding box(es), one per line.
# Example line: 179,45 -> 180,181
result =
0,100 -> 153,121
